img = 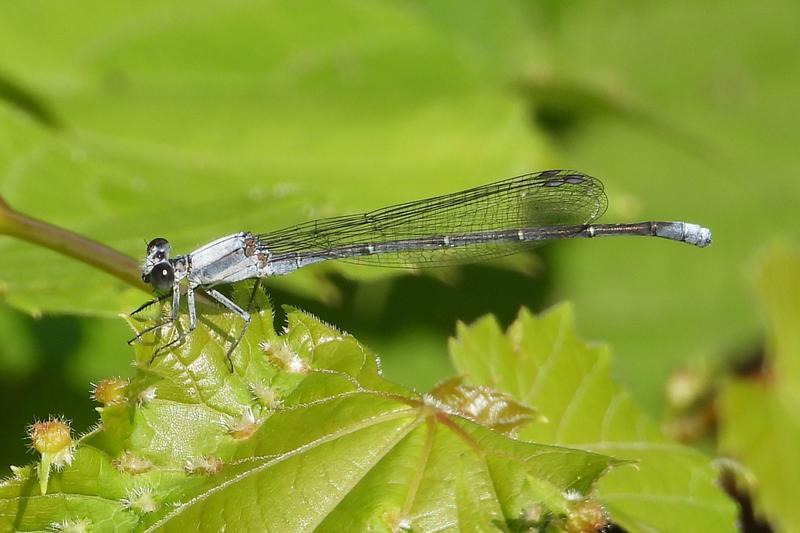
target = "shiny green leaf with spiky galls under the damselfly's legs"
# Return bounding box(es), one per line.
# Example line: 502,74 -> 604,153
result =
0,293 -> 621,531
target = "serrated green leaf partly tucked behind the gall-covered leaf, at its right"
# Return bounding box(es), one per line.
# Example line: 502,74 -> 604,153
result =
450,305 -> 736,532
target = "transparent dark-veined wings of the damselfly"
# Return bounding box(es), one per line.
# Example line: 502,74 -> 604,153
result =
256,170 -> 608,267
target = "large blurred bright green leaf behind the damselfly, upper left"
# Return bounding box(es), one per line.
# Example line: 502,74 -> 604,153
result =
0,0 -> 541,316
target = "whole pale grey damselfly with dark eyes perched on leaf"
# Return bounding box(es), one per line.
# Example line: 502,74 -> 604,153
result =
137,170 -> 711,367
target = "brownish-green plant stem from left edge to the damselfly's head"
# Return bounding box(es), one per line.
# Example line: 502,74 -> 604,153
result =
0,196 -> 152,293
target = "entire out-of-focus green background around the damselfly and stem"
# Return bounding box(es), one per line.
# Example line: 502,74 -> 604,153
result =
0,0 -> 800,512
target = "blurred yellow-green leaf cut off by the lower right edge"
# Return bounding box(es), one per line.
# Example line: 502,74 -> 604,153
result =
720,246 -> 800,531
